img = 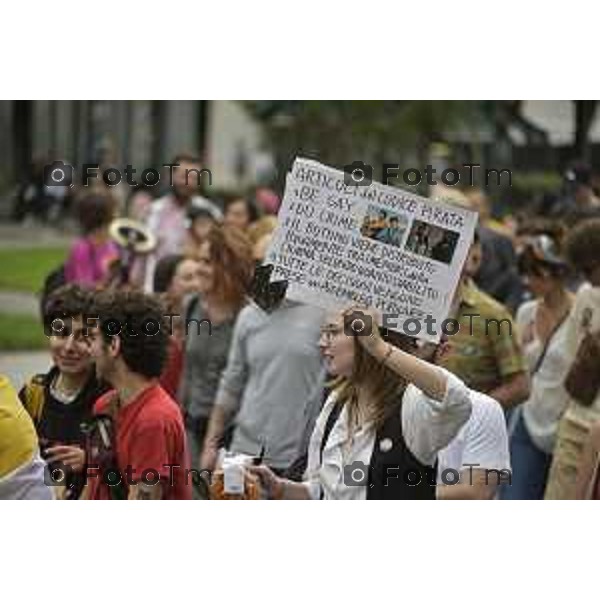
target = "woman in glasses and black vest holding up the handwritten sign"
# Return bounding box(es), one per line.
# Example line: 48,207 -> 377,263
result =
251,310 -> 471,500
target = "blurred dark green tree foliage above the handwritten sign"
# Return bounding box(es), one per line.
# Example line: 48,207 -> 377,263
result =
245,100 -> 597,188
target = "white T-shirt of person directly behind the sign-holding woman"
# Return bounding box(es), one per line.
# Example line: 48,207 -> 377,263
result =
438,390 -> 510,485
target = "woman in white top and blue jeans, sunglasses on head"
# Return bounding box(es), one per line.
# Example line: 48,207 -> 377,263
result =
500,234 -> 573,500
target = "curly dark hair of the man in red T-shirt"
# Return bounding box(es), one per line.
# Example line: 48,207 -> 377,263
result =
91,290 -> 169,378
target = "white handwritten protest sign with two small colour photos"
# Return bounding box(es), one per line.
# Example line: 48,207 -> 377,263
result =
266,159 -> 477,341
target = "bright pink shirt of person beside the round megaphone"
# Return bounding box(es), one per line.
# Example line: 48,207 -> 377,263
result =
65,238 -> 119,287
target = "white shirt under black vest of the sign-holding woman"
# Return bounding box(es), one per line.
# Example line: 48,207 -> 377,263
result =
305,367 -> 471,500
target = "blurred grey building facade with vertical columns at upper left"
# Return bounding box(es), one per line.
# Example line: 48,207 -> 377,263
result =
0,100 -> 268,190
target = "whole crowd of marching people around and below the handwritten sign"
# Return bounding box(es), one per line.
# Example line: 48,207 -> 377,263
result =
0,155 -> 600,499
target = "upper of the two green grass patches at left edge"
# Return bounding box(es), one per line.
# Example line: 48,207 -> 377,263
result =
0,248 -> 68,293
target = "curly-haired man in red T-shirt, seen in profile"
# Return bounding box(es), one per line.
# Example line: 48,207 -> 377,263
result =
83,291 -> 192,500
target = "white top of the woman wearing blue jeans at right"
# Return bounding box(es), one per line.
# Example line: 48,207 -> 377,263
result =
517,300 -> 572,454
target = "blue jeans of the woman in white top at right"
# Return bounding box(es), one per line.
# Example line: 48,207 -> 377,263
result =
499,410 -> 552,500
